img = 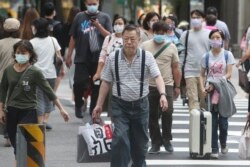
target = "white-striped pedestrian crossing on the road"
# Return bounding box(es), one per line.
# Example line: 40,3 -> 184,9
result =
102,99 -> 250,167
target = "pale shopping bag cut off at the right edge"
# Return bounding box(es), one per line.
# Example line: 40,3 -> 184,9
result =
239,121 -> 250,160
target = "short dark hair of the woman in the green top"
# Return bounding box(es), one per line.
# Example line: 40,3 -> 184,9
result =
13,40 -> 37,64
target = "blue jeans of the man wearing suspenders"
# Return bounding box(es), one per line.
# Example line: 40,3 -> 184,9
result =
111,96 -> 149,167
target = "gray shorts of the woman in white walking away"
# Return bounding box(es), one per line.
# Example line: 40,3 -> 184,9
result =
36,79 -> 56,116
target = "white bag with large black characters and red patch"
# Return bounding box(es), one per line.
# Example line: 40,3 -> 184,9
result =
79,124 -> 113,156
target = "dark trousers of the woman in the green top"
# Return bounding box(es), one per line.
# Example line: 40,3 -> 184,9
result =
7,107 -> 38,154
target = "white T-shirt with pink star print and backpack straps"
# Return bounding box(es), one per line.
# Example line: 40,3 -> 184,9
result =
201,49 -> 235,78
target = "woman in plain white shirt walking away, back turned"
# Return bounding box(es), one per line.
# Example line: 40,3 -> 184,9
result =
30,18 -> 61,129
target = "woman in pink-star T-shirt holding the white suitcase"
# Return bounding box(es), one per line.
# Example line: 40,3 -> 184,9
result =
200,29 -> 235,159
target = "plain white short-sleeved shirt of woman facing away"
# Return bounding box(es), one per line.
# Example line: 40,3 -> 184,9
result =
30,36 -> 61,79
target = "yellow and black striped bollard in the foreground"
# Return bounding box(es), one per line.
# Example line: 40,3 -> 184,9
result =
16,124 -> 45,167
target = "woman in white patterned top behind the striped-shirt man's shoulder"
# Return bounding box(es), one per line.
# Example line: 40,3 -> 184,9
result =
93,16 -> 126,81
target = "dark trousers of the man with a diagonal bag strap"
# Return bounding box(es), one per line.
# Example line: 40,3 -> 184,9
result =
148,86 -> 174,145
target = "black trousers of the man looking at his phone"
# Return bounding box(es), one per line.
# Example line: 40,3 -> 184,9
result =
73,62 -> 100,114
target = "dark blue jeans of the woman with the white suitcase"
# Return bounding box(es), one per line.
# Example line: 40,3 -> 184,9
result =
211,105 -> 228,153
